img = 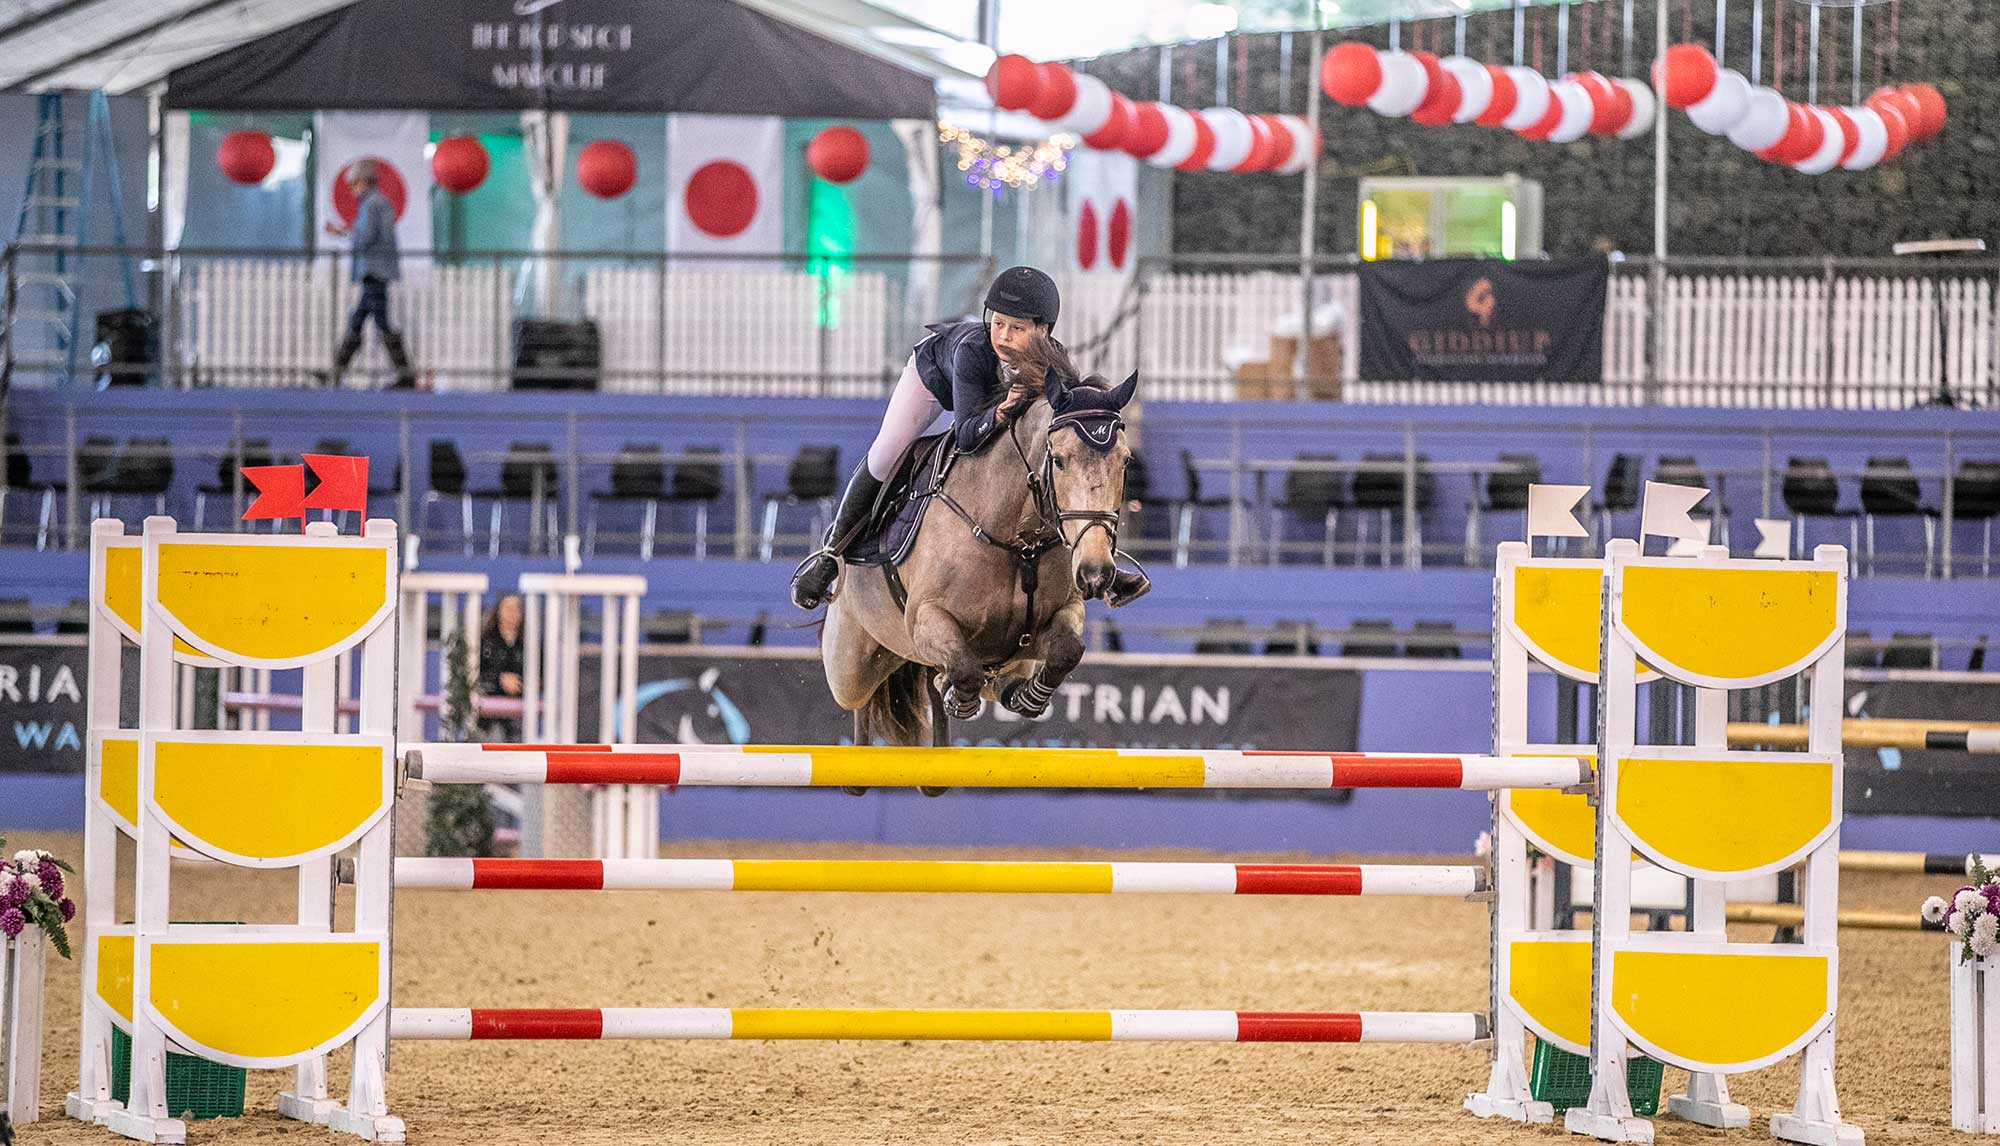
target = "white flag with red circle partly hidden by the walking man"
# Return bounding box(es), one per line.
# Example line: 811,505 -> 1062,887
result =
312,112 -> 430,255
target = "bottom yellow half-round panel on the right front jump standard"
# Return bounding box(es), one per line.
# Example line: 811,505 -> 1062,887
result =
1608,944 -> 1834,1074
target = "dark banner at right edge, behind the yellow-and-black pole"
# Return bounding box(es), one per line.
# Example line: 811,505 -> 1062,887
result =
1844,680 -> 2000,818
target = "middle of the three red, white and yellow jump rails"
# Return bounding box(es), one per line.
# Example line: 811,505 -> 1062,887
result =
396,856 -> 1486,896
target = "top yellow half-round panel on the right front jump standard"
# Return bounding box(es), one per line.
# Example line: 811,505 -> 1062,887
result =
1618,564 -> 1840,688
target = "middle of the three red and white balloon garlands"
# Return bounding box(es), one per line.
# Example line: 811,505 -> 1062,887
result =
1320,40 -> 1654,144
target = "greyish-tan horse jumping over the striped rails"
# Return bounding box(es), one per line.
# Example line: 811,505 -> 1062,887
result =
820,340 -> 1138,746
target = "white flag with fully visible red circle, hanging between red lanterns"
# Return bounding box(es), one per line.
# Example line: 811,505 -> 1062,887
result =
666,116 -> 776,256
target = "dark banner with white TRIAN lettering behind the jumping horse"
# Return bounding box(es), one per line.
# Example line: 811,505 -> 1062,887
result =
578,654 -> 1360,750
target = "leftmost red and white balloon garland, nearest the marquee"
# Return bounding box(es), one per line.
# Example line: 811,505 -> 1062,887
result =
986,56 -> 1322,174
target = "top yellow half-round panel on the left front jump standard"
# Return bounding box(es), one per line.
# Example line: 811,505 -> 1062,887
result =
156,538 -> 394,668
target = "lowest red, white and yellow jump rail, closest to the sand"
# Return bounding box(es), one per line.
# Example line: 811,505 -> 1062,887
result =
388,1006 -> 1486,1044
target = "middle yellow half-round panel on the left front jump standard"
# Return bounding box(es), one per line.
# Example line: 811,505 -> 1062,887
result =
152,738 -> 392,866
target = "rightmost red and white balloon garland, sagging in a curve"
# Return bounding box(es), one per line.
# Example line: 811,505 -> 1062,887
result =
1654,44 -> 1944,174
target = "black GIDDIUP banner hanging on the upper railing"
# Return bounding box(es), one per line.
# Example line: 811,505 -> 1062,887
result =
1360,258 -> 1610,382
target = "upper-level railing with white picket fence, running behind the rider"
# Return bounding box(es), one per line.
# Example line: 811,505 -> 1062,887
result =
0,244 -> 2000,408
